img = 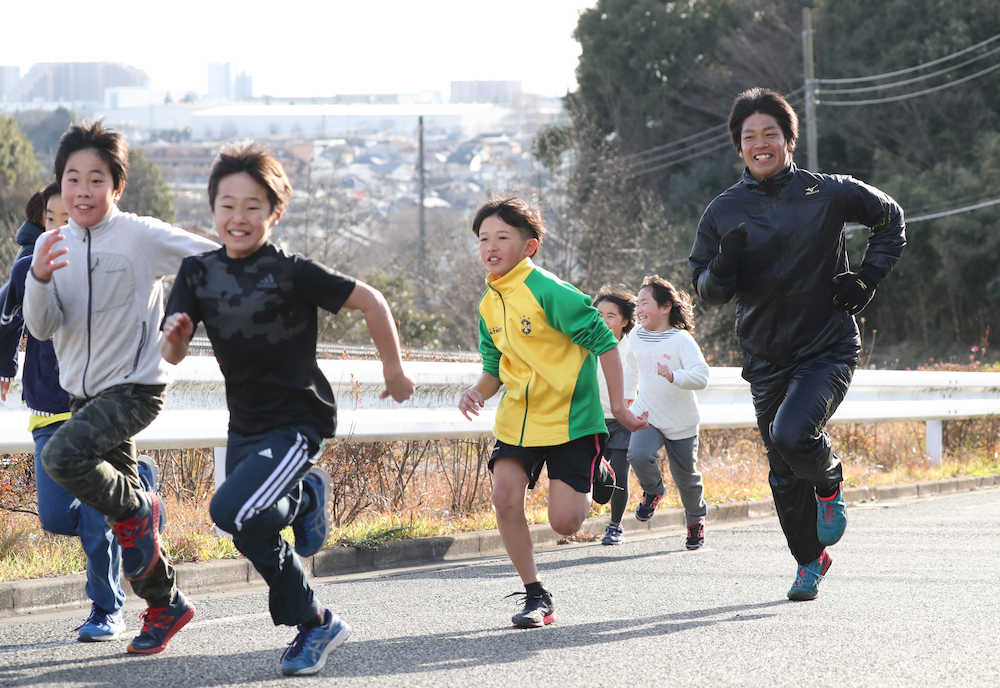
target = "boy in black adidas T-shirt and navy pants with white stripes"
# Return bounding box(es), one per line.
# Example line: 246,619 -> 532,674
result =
162,144 -> 413,674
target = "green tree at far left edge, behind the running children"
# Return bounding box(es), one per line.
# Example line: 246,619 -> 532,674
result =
0,115 -> 41,270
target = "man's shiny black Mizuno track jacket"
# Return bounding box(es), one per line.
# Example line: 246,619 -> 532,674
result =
688,163 -> 906,381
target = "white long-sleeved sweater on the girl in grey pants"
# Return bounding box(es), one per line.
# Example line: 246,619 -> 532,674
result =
625,327 -> 708,440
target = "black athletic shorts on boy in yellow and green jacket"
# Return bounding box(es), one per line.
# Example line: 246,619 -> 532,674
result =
489,434 -> 608,493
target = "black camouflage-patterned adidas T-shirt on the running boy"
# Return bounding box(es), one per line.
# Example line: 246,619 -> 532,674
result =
166,243 -> 355,437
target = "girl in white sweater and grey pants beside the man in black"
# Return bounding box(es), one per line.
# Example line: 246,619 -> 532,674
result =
625,275 -> 708,550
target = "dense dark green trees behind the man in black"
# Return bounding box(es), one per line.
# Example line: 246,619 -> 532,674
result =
560,0 -> 1000,364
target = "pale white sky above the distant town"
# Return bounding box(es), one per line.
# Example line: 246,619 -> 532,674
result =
0,0 -> 597,99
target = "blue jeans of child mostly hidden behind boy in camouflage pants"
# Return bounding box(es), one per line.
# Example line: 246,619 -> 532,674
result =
31,423 -> 125,612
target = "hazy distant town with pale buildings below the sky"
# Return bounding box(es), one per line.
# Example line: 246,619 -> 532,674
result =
0,62 -> 565,239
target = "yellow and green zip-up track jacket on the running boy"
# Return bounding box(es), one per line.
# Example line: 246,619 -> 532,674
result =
479,258 -> 618,447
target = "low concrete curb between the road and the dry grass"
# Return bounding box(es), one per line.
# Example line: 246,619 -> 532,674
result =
0,475 -> 1000,618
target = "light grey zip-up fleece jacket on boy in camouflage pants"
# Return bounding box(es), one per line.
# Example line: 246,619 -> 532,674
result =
24,206 -> 218,398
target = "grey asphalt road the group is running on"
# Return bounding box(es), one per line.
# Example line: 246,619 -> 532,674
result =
0,489 -> 1000,688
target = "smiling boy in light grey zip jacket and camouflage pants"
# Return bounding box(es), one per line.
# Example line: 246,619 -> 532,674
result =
24,122 -> 215,654
